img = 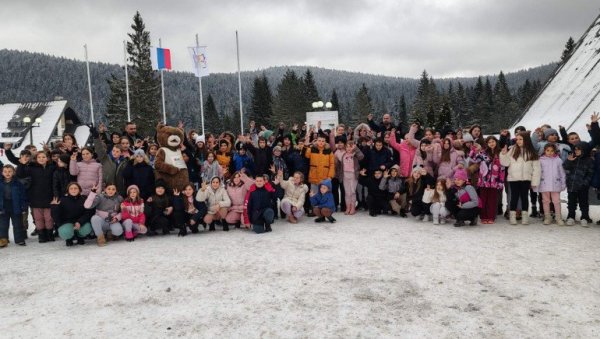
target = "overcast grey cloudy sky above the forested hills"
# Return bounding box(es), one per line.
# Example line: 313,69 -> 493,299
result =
0,0 -> 600,77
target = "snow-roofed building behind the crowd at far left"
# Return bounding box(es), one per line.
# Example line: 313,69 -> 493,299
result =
0,98 -> 89,164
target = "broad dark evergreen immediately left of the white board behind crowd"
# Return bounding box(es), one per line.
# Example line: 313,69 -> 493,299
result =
273,69 -> 308,126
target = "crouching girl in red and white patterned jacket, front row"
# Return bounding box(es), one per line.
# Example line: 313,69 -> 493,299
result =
121,185 -> 148,241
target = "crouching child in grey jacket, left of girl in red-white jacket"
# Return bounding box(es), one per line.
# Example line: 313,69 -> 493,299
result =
84,184 -> 123,246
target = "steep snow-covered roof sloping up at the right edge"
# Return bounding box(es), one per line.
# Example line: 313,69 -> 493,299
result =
513,16 -> 600,140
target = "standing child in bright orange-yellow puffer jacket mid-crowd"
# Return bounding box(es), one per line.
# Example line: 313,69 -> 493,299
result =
304,133 -> 335,192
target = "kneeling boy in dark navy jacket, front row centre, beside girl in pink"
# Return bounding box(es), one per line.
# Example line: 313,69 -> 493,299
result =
247,176 -> 275,233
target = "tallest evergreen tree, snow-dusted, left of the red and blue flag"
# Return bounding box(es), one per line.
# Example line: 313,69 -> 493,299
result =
127,12 -> 162,135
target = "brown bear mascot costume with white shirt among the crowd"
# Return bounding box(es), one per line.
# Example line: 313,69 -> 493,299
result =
154,123 -> 190,191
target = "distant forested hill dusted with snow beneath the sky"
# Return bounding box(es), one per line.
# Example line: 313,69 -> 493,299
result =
0,49 -> 557,125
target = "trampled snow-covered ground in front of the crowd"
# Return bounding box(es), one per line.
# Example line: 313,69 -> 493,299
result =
0,211 -> 600,338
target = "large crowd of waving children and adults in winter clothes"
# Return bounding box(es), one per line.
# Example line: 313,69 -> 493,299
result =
0,113 -> 600,247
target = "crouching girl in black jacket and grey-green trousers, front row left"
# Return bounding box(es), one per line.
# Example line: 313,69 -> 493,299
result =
50,182 -> 94,246
